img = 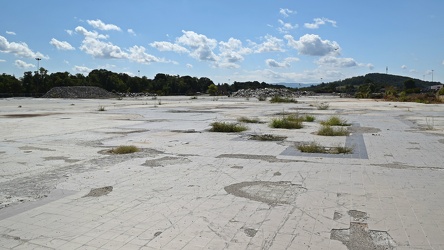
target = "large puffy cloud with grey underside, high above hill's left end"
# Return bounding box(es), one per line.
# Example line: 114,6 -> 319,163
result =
284,34 -> 340,56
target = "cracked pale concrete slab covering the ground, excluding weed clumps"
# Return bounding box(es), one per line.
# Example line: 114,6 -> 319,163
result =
0,96 -> 444,250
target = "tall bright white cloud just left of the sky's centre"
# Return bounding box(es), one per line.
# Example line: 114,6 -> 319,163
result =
177,30 -> 218,62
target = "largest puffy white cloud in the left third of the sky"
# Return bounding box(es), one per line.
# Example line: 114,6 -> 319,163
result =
80,37 -> 128,59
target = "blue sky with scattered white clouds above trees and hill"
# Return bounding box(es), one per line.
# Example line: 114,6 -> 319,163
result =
0,0 -> 444,83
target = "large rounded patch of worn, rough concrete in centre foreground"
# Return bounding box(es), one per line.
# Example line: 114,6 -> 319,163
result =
225,181 -> 306,206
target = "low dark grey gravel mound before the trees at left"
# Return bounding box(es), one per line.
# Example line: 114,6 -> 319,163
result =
42,86 -> 117,99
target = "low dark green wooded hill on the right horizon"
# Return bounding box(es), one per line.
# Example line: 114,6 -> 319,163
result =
296,73 -> 441,93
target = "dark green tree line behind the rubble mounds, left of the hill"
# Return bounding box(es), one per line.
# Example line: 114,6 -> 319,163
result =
0,67 -> 285,97
